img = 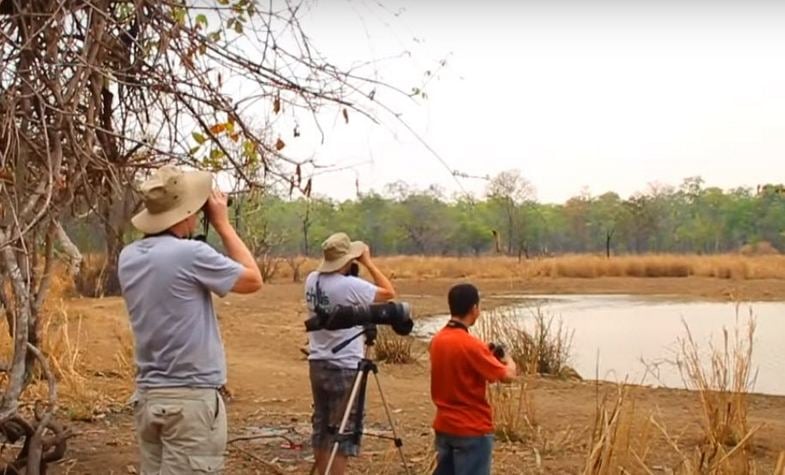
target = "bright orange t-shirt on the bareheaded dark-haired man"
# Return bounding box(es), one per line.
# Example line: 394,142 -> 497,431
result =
430,327 -> 507,436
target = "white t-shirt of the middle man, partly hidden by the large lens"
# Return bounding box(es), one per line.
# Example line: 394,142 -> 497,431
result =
305,272 -> 377,369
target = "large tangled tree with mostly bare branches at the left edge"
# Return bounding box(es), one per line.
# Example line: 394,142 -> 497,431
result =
0,0 -> 414,475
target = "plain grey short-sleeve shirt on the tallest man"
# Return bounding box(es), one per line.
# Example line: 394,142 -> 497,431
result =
118,235 -> 243,388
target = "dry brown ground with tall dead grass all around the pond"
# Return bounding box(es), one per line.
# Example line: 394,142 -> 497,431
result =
0,255 -> 785,474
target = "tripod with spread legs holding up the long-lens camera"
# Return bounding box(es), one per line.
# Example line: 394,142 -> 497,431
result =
326,325 -> 411,475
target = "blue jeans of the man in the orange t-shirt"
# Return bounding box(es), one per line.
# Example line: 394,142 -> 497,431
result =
433,432 -> 493,475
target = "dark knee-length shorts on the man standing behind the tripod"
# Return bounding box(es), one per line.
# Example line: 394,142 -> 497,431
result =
309,360 -> 362,457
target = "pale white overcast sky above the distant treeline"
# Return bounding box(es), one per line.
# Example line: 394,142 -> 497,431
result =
253,0 -> 785,202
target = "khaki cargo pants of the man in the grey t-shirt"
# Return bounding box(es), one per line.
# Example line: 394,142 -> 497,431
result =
134,388 -> 226,475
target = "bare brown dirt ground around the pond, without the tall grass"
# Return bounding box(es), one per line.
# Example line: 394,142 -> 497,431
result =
36,278 -> 785,474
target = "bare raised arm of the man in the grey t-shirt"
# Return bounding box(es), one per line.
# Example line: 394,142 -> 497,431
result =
207,190 -> 263,294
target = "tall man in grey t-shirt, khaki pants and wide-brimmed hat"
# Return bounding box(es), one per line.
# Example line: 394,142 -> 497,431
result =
118,166 -> 262,475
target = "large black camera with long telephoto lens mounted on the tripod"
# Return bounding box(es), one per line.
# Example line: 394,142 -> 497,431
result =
305,302 -> 414,336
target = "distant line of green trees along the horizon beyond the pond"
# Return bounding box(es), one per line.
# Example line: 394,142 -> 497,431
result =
64,171 -> 785,257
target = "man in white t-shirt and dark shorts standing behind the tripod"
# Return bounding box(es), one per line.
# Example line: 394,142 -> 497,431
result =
305,233 -> 395,475
